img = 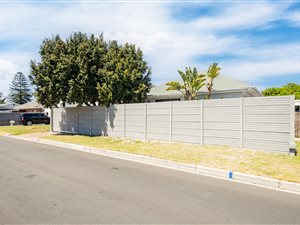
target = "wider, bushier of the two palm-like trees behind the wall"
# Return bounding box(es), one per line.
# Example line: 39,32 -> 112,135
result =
166,67 -> 205,100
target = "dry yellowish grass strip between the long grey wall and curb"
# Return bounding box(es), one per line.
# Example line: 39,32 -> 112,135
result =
43,135 -> 300,183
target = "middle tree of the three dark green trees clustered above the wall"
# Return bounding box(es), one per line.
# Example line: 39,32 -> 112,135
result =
67,33 -> 108,105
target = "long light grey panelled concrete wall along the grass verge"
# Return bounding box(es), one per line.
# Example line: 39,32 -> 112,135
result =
51,96 -> 295,154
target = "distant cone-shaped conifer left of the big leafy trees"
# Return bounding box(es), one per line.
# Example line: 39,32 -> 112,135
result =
8,72 -> 32,104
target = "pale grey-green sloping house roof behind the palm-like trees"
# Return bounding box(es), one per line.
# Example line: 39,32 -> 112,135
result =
149,75 -> 253,96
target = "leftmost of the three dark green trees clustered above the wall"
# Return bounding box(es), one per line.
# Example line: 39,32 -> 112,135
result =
29,35 -> 69,107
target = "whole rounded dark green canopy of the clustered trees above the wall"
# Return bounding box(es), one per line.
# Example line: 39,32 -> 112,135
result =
30,32 -> 151,107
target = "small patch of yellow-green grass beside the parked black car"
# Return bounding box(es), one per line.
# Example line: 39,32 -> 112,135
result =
0,125 -> 50,135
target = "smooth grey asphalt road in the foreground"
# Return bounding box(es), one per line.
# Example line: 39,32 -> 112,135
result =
0,134 -> 300,224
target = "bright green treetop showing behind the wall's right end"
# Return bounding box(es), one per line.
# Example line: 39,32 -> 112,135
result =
262,83 -> 300,99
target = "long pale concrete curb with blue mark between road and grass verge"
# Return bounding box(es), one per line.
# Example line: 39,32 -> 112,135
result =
4,135 -> 300,194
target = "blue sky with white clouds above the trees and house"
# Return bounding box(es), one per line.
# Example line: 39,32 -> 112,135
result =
0,0 -> 300,95
